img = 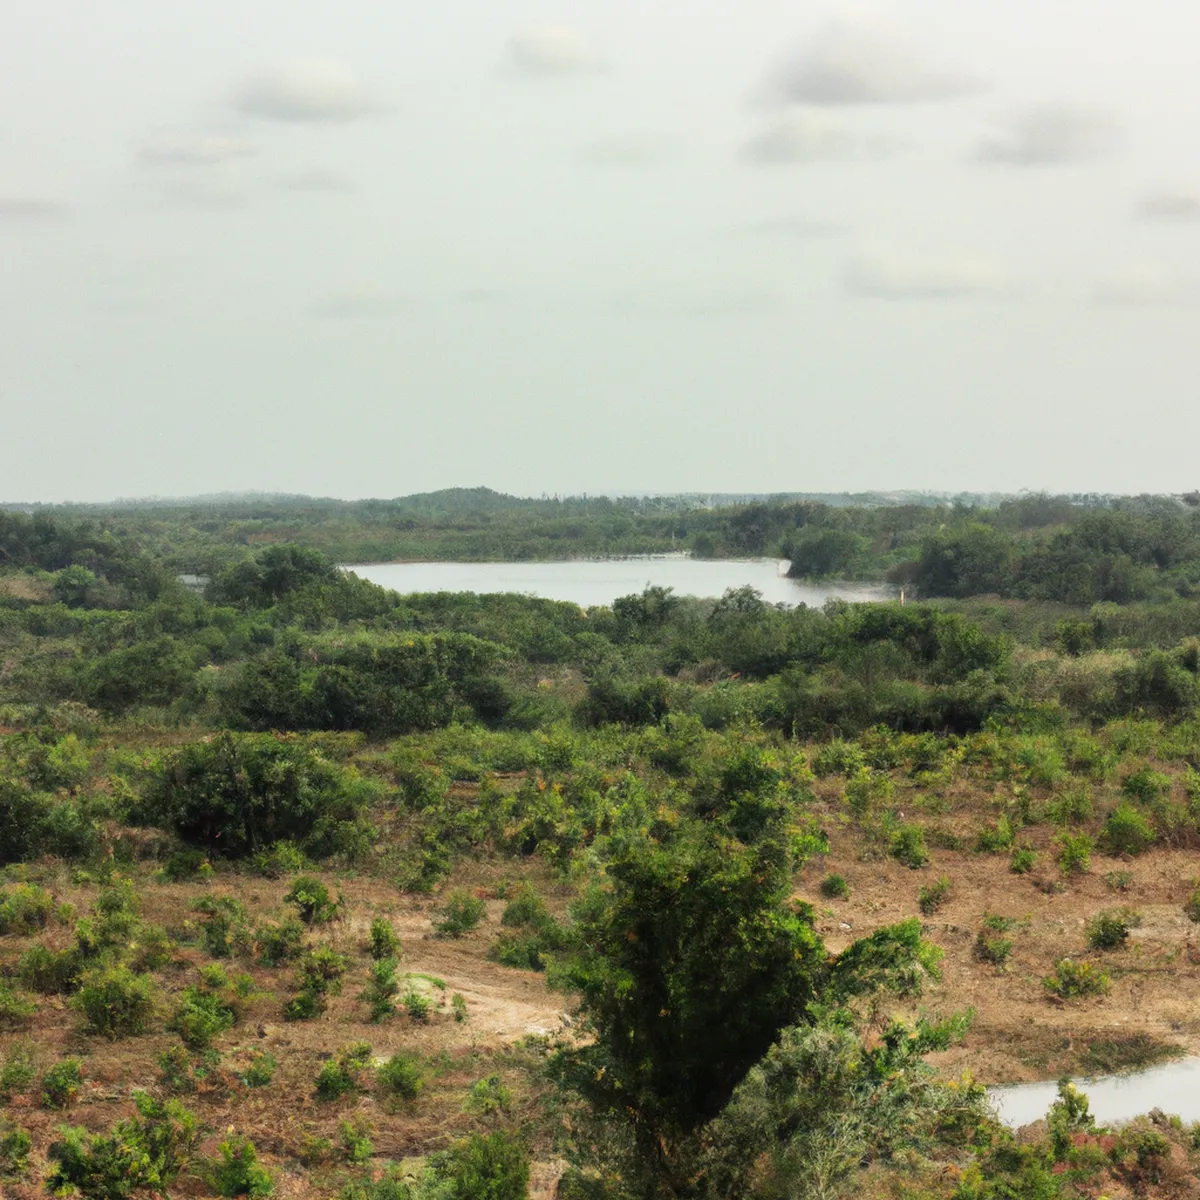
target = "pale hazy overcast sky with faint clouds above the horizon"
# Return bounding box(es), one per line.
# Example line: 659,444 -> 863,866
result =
0,0 -> 1200,502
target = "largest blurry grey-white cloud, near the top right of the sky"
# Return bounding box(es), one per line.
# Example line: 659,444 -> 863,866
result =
774,22 -> 980,104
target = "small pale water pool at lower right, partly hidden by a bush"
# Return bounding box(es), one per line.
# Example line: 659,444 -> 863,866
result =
988,1058 -> 1200,1129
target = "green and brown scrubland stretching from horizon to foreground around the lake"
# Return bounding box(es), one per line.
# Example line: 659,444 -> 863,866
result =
0,493 -> 1200,1200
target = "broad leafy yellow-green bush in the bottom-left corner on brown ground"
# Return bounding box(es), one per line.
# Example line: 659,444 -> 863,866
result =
46,1092 -> 199,1200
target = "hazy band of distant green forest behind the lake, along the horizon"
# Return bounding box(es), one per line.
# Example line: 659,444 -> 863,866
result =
0,488 -> 1200,606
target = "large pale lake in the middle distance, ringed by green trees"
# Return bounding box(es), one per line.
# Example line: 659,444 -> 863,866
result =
350,554 -> 890,608
